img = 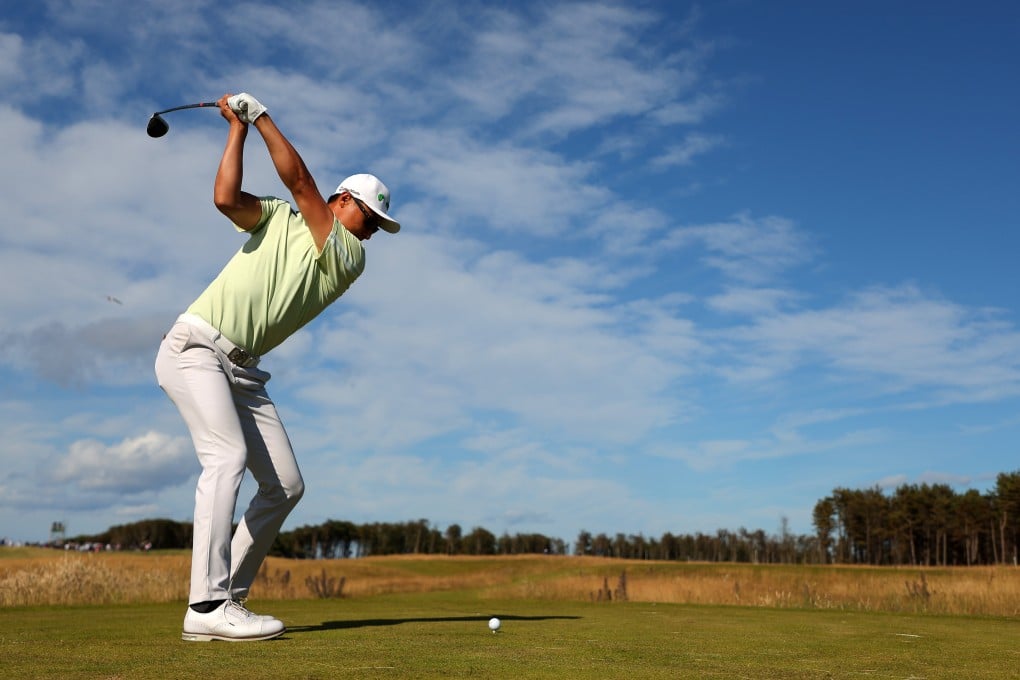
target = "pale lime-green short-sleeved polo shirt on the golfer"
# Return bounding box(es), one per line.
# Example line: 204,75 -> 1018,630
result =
188,197 -> 365,357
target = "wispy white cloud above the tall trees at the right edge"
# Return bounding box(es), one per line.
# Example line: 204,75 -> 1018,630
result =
733,285 -> 1020,401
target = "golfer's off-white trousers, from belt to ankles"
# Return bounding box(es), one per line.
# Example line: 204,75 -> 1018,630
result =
150,319 -> 304,604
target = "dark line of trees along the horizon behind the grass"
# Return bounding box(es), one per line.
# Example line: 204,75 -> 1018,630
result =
57,471 -> 1020,566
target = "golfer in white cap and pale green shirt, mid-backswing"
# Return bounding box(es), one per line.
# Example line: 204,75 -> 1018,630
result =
156,93 -> 400,641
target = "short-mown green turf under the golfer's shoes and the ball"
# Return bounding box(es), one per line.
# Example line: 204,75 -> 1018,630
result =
0,591 -> 1020,680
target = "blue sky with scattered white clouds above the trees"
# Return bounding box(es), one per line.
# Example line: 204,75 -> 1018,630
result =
0,0 -> 1020,541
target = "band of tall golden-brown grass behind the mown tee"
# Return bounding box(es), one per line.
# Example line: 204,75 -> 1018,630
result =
0,548 -> 1020,616
